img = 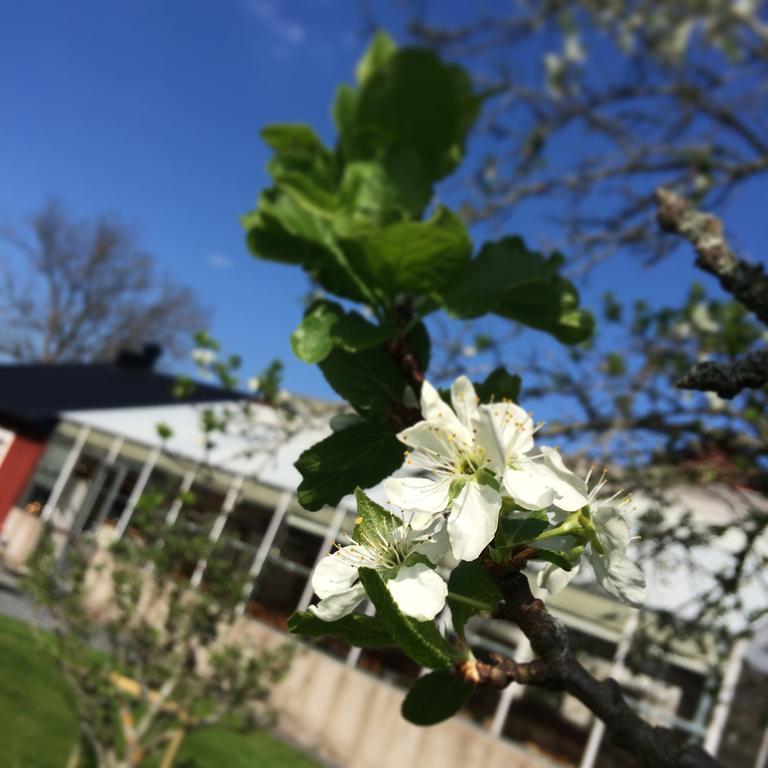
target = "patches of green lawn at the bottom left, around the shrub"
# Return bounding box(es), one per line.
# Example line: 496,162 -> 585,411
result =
0,616 -> 317,768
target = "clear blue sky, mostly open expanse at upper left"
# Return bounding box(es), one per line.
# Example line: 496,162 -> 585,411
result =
0,0 -> 765,408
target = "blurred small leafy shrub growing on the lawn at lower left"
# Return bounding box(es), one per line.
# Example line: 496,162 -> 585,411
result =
26,493 -> 293,768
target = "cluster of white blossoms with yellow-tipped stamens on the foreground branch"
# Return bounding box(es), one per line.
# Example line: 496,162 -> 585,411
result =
312,376 -> 644,621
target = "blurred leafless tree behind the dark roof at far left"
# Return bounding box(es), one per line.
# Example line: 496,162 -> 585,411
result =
0,200 -> 208,363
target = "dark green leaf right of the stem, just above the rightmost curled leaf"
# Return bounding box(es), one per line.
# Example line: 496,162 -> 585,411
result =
444,237 -> 558,318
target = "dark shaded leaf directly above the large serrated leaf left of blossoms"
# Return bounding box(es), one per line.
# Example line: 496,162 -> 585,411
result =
320,346 -> 408,416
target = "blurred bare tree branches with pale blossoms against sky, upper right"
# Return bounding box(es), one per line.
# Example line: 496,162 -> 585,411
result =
407,0 -> 768,264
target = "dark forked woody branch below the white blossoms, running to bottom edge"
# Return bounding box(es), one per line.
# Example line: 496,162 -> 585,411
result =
460,572 -> 719,768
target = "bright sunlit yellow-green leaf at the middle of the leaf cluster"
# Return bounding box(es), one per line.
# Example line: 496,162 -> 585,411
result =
341,206 -> 472,301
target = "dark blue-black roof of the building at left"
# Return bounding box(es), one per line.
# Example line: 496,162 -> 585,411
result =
0,356 -> 244,432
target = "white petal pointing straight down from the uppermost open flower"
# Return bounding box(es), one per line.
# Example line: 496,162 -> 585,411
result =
448,482 -> 501,560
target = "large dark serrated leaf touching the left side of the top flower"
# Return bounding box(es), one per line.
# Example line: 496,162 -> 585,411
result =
295,422 -> 403,511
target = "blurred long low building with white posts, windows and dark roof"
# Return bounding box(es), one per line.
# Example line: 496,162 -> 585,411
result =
0,356 -> 768,768
